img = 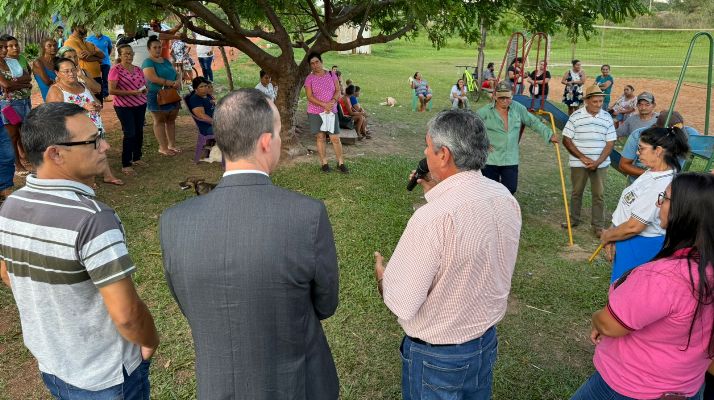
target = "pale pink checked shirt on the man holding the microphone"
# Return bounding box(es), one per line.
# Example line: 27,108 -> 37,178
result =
383,171 -> 521,344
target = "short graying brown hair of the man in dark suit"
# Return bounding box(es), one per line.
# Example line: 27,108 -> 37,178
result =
213,89 -> 279,161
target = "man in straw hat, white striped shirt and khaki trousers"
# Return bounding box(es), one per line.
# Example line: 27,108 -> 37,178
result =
563,85 -> 617,234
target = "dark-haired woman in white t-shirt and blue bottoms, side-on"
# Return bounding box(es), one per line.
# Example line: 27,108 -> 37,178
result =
600,127 -> 689,282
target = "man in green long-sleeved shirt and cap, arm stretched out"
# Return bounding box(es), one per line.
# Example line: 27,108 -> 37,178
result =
478,82 -> 558,193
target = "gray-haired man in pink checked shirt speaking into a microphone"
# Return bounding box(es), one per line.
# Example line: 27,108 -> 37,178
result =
375,110 -> 521,400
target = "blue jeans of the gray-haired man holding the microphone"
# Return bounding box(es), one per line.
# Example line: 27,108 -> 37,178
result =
400,327 -> 498,400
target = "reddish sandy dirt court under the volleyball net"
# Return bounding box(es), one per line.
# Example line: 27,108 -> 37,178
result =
604,78 -> 714,134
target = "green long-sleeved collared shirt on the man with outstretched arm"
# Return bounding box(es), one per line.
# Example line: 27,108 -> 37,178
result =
478,102 -> 553,166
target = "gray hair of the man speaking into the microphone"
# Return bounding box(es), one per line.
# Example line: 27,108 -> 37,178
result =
427,110 -> 488,171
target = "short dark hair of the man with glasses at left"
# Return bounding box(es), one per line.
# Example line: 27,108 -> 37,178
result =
20,104 -> 87,166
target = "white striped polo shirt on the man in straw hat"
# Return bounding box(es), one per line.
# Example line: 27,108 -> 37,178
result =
563,107 -> 617,168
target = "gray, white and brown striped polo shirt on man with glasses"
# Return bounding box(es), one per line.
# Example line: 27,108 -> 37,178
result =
0,175 -> 141,390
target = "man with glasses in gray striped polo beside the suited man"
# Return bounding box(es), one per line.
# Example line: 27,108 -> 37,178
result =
0,103 -> 159,400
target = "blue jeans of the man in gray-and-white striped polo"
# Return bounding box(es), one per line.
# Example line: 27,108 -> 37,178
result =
42,360 -> 151,400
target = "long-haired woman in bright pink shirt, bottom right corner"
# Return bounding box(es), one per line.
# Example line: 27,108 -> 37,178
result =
571,173 -> 714,400
